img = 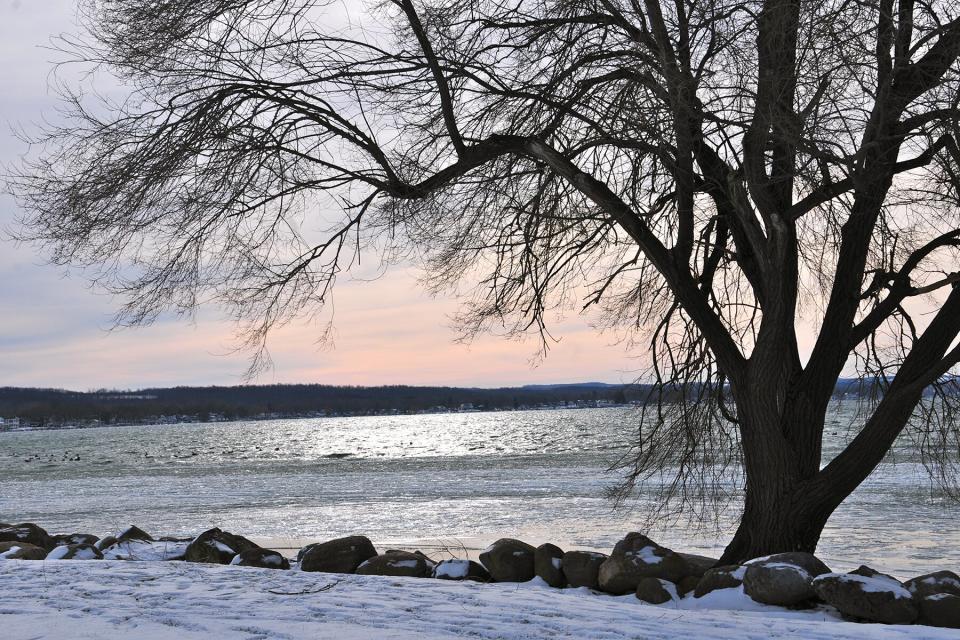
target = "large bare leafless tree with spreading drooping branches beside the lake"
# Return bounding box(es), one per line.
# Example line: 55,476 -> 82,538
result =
11,0 -> 960,562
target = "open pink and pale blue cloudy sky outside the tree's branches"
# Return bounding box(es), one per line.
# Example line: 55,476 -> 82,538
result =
0,0 -> 642,390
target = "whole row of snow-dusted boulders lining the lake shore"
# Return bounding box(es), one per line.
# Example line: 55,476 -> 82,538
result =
0,523 -> 960,628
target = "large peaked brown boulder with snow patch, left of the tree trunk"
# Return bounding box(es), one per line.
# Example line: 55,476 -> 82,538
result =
598,533 -> 695,595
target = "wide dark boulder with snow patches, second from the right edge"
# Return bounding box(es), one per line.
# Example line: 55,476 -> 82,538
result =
812,571 -> 919,624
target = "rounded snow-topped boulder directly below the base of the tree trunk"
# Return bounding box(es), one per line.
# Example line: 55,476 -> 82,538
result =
743,551 -> 830,607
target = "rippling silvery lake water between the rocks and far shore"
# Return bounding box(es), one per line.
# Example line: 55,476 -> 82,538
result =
0,409 -> 960,577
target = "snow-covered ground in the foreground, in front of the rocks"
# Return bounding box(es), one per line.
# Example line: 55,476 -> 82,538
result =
0,560 -> 960,640
